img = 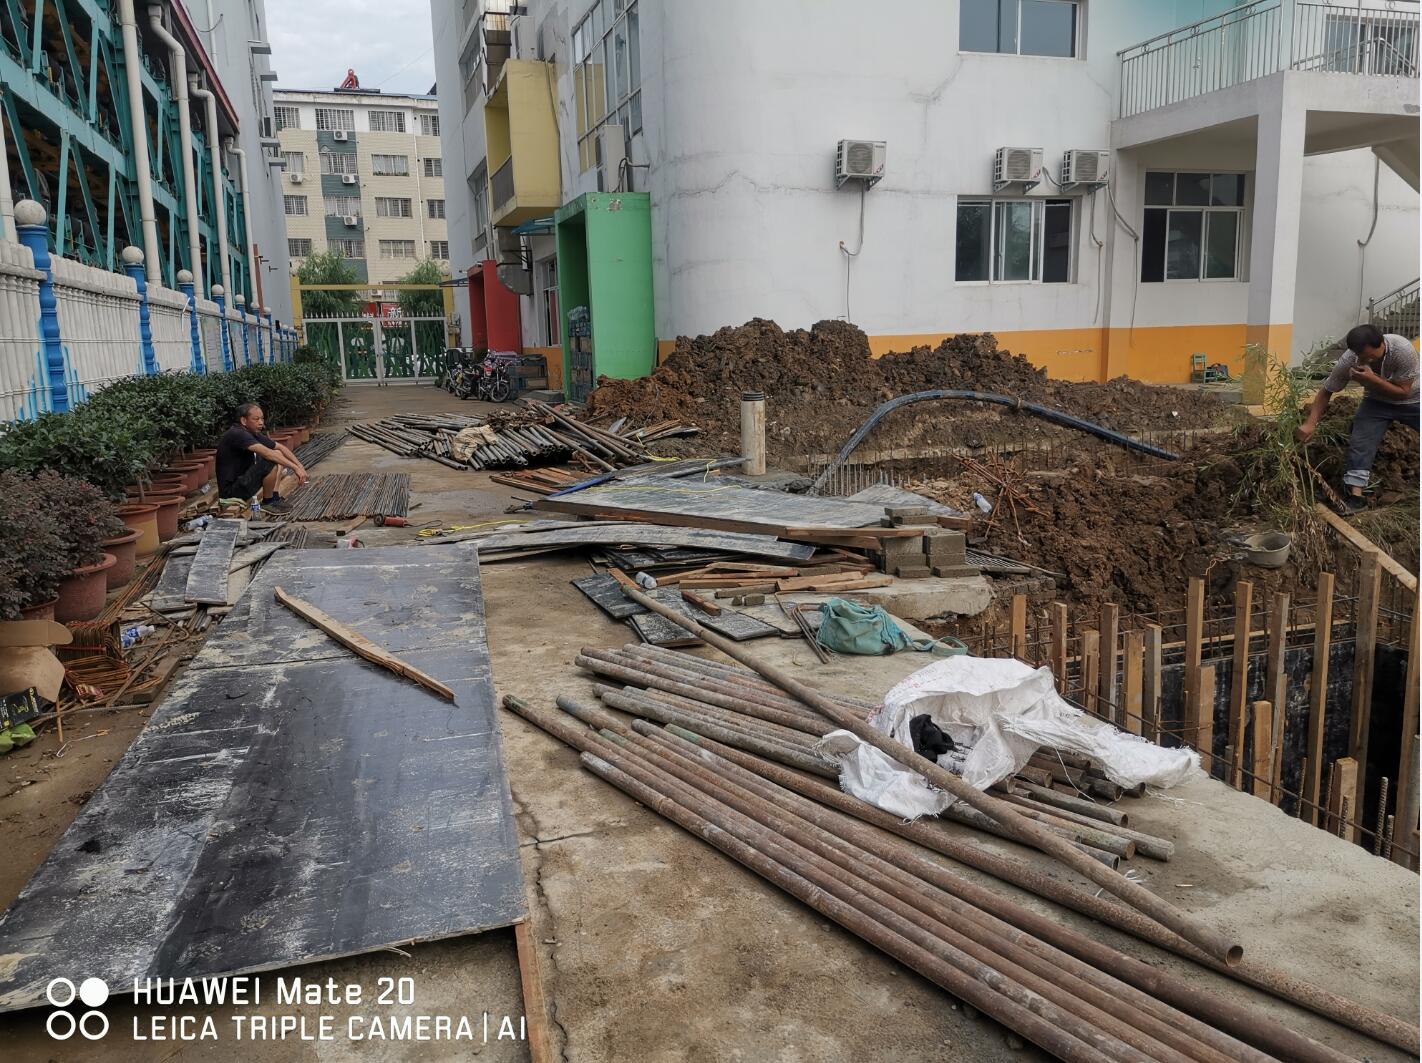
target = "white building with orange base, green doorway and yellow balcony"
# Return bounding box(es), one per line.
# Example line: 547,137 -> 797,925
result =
432,0 -> 1419,394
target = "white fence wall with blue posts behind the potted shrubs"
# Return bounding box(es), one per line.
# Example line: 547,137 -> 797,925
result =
0,202 -> 297,421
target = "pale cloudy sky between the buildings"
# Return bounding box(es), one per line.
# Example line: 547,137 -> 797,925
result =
266,0 -> 435,92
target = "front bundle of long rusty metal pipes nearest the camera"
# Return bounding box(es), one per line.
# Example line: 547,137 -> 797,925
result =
503,696 -> 1376,1063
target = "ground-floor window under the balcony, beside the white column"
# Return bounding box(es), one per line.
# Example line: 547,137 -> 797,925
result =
1140,171 -> 1244,281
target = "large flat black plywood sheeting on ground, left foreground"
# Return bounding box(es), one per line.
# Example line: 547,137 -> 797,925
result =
0,547 -> 526,1010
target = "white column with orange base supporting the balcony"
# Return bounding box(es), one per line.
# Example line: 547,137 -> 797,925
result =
1244,87 -> 1308,404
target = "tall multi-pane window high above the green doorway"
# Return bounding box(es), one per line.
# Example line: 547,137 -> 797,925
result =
573,0 -> 641,171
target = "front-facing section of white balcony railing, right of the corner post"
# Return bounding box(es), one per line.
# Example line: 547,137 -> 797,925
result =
1290,0 -> 1418,78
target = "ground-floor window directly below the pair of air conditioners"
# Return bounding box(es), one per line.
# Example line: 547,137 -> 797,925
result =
953,196 -> 1075,284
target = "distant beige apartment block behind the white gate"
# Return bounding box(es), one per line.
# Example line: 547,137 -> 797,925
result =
276,88 -> 449,283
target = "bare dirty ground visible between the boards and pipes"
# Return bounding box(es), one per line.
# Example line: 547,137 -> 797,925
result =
0,388 -> 1418,1063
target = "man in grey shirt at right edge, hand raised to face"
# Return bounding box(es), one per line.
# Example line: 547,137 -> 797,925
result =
1295,325 -> 1418,513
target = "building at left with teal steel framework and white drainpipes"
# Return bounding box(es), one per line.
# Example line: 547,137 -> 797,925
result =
0,0 -> 290,320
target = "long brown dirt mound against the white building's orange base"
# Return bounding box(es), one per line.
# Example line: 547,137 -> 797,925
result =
589,318 -> 1223,463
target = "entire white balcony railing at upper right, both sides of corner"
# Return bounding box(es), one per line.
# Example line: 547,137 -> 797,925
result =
1118,0 -> 1419,118
